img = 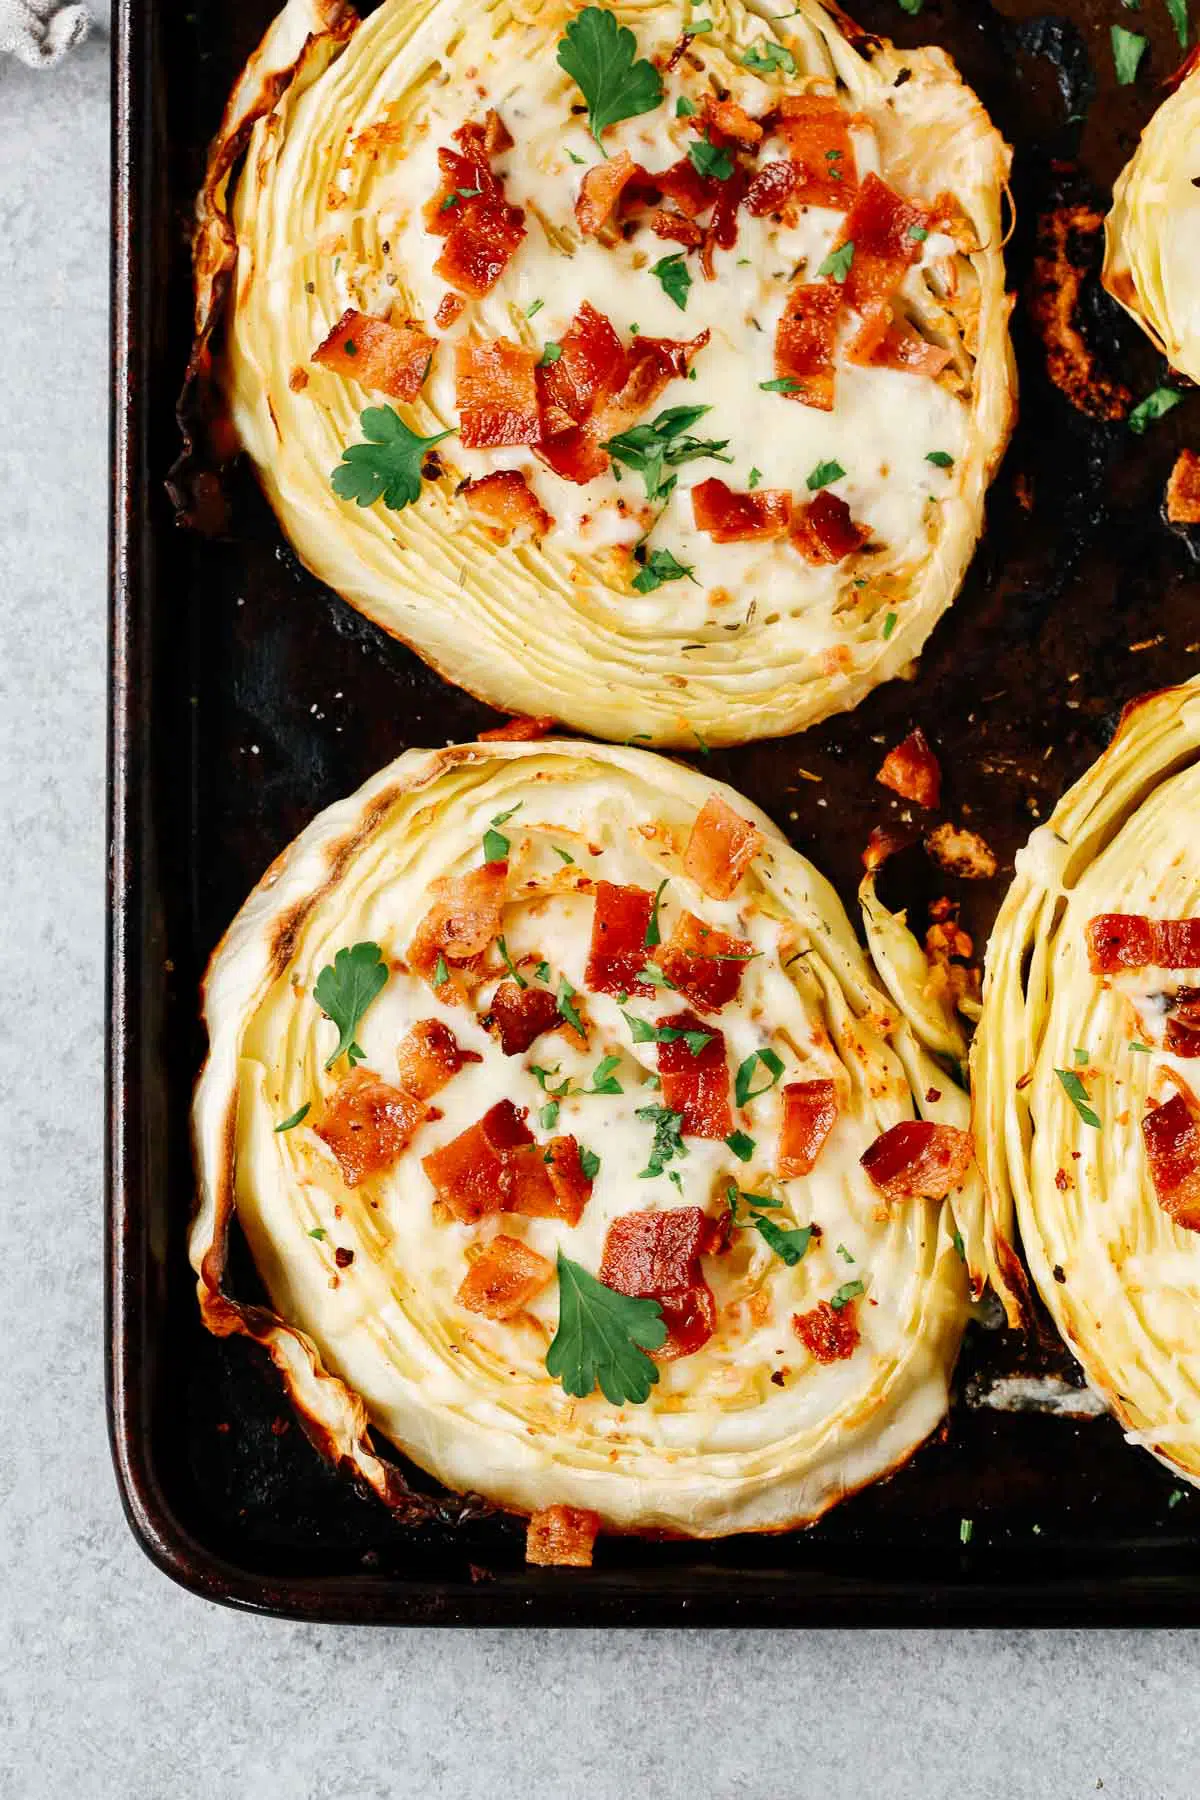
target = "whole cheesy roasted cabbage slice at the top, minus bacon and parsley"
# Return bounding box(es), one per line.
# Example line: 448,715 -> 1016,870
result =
213,0 -> 1011,743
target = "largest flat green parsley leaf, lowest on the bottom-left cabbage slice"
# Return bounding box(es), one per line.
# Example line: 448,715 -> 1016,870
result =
545,1252 -> 667,1406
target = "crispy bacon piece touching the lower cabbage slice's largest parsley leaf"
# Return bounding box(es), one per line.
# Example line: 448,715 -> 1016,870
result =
599,1206 -> 716,1363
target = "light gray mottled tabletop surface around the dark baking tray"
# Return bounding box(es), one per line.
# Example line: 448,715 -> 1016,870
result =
0,28 -> 1200,1800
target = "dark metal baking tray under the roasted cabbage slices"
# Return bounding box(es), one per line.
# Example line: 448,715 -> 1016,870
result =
108,0 -> 1200,1625
